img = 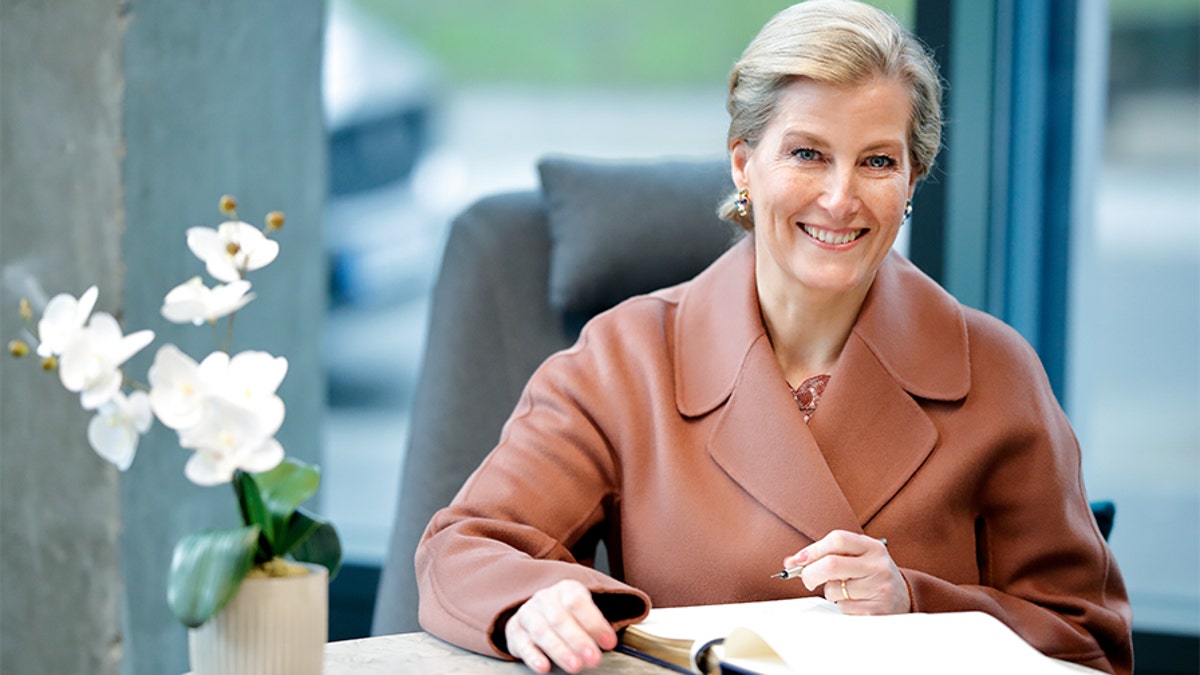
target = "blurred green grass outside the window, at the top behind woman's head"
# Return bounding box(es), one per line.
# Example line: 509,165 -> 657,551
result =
342,0 -> 913,86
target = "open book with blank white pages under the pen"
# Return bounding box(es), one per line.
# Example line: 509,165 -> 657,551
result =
618,598 -> 1096,675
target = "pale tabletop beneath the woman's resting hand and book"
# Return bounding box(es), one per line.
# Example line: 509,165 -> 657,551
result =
324,633 -> 671,675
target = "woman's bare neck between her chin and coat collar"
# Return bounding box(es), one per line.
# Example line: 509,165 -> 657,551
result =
756,266 -> 870,387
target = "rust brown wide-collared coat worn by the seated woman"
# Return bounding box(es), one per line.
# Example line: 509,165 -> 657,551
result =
416,236 -> 1132,673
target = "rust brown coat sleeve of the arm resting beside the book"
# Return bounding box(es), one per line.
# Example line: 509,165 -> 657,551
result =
415,330 -> 649,658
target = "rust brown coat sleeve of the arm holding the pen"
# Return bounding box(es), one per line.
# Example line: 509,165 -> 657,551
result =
902,312 -> 1133,674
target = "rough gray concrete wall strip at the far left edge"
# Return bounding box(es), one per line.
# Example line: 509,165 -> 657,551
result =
0,0 -> 124,675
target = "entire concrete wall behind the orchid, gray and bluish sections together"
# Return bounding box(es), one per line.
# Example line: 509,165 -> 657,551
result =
0,0 -> 325,675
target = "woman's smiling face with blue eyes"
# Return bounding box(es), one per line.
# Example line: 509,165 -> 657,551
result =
731,74 -> 916,302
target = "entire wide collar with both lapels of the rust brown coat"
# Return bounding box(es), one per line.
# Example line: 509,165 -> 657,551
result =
674,238 -> 971,539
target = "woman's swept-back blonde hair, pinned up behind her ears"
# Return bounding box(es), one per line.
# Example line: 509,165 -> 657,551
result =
718,0 -> 942,229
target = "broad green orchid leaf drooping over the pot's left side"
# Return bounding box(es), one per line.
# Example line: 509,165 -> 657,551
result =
167,525 -> 259,628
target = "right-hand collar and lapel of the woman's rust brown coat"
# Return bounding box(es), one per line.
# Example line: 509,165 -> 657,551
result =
809,253 -> 971,526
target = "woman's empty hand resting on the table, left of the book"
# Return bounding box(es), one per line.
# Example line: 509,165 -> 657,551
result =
504,579 -> 617,673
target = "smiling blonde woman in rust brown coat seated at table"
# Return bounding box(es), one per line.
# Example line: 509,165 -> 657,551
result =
416,0 -> 1132,673
